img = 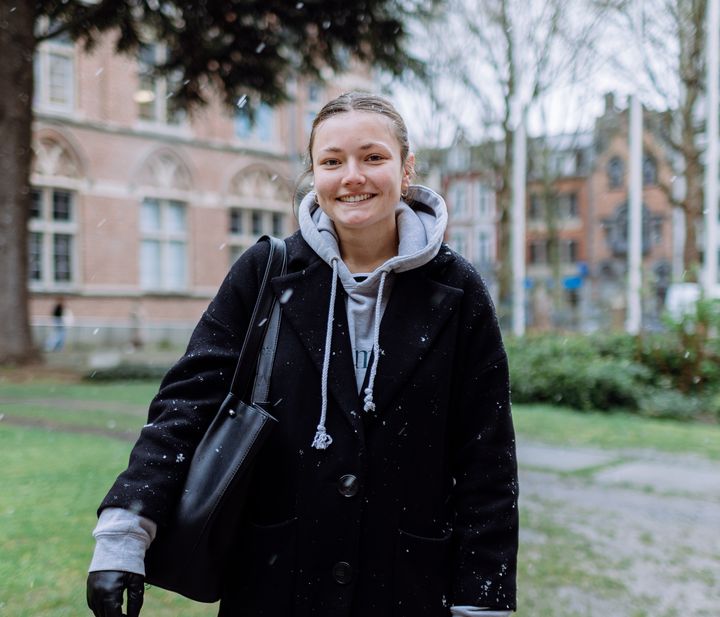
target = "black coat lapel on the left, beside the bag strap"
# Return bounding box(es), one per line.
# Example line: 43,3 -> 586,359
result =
272,260 -> 363,439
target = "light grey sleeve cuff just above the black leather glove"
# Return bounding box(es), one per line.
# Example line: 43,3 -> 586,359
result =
88,508 -> 157,576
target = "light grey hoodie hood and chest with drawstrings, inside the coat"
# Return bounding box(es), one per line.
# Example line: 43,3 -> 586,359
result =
299,185 -> 447,450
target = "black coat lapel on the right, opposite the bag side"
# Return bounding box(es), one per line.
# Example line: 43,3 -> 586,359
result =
363,269 -> 463,416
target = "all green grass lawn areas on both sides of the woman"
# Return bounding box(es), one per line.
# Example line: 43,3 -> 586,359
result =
0,382 -> 720,617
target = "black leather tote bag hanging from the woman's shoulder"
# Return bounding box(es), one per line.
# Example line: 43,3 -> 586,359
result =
145,236 -> 287,602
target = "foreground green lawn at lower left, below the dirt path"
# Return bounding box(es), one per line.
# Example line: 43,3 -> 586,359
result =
0,424 -> 216,617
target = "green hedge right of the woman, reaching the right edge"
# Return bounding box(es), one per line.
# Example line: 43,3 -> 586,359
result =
506,301 -> 720,422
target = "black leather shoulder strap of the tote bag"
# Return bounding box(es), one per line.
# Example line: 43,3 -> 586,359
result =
230,236 -> 287,402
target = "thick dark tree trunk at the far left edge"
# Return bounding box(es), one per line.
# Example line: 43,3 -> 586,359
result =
0,0 -> 37,363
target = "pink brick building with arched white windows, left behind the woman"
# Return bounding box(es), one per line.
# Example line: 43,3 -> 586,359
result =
29,31 -> 372,344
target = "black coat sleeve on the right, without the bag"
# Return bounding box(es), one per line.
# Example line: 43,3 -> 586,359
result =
451,274 -> 518,610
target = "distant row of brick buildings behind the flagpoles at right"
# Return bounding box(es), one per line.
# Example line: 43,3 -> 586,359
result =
425,95 -> 673,329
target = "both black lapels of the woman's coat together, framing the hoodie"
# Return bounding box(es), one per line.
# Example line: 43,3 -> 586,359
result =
272,236 -> 463,440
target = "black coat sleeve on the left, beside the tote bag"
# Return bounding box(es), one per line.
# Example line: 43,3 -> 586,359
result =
98,242 -> 268,525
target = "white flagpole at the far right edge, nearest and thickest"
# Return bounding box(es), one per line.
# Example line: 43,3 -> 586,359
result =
703,0 -> 720,297
